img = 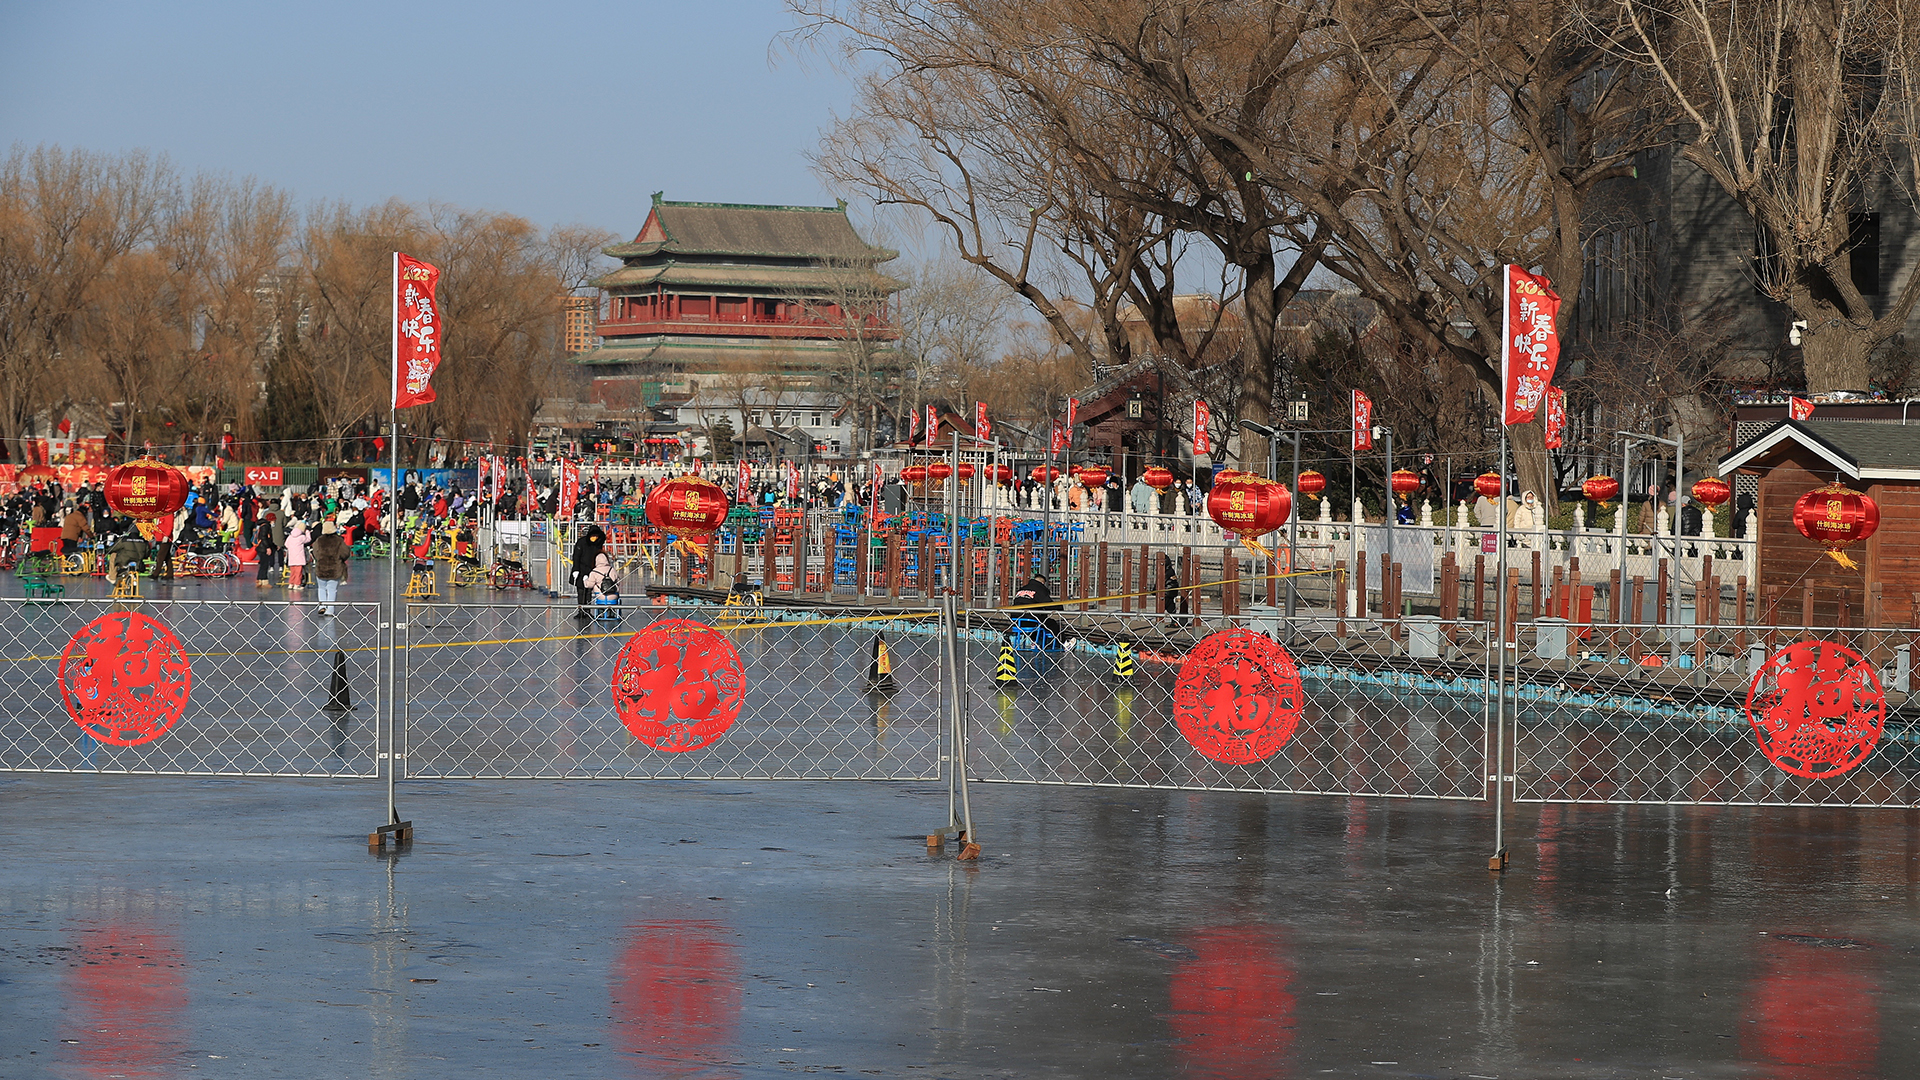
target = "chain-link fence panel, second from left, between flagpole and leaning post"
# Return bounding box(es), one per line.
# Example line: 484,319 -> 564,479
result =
401,598 -> 945,780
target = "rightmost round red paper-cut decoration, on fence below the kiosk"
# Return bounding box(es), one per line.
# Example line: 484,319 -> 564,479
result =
1747,642 -> 1887,780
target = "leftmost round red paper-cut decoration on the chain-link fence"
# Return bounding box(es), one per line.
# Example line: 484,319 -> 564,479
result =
60,611 -> 194,746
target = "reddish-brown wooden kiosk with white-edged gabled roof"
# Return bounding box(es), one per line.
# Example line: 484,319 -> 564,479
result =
1720,421 -> 1920,626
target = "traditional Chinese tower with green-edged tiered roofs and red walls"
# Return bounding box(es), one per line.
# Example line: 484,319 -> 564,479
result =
574,192 -> 904,405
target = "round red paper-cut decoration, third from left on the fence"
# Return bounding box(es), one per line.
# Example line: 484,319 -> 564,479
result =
1173,630 -> 1304,765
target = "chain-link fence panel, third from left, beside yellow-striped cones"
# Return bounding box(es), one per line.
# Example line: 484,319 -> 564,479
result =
966,600 -> 1490,799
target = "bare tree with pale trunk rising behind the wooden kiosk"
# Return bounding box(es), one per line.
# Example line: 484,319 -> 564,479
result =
1617,0 -> 1920,390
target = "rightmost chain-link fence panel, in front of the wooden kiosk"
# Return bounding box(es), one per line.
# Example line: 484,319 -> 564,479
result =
1507,623 -> 1920,807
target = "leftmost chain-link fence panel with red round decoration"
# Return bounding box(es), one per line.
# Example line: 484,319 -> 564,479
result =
0,600 -> 382,776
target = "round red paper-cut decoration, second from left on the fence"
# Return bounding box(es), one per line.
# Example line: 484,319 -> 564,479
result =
612,619 -> 747,753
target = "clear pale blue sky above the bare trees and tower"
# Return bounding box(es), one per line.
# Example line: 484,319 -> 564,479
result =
0,0 -> 851,234
